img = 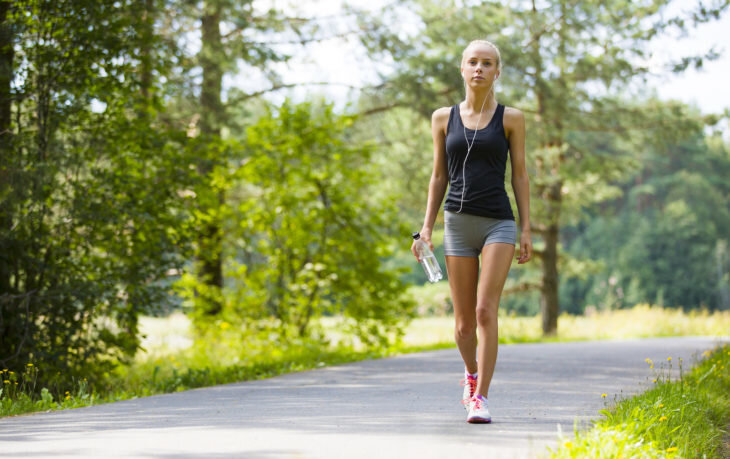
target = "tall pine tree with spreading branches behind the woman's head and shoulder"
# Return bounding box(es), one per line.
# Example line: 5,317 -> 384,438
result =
352,0 -> 727,334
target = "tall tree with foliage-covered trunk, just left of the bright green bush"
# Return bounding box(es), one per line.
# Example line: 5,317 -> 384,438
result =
162,0 -> 342,318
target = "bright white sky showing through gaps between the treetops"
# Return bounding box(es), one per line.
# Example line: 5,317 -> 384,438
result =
246,0 -> 730,114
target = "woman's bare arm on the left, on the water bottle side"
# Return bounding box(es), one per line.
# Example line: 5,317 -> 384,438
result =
411,107 -> 450,258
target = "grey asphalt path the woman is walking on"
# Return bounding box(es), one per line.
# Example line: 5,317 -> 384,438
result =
0,337 -> 722,459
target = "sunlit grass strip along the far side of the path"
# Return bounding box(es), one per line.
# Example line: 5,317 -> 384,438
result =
0,306 -> 730,417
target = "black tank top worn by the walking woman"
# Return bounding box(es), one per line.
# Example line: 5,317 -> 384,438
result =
444,104 -> 515,220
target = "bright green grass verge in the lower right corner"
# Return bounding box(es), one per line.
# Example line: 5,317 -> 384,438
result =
550,345 -> 730,459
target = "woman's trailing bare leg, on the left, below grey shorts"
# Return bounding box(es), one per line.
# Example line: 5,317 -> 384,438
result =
446,256 -> 479,373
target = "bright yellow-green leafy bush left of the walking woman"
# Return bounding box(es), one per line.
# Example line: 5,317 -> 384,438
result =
176,103 -> 411,345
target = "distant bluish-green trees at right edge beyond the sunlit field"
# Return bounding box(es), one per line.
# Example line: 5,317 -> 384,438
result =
564,129 -> 730,312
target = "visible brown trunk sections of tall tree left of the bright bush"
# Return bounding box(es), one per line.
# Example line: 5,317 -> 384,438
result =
198,0 -> 224,315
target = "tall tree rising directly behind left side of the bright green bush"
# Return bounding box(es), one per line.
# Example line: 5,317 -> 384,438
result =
168,0 -> 315,316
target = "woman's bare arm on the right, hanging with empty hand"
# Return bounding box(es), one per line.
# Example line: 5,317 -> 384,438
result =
504,107 -> 532,264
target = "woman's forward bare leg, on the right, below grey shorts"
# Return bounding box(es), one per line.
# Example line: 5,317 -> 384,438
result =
472,242 -> 515,397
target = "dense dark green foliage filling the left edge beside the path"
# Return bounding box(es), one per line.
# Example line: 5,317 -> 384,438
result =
0,0 -> 195,389
